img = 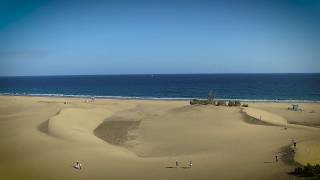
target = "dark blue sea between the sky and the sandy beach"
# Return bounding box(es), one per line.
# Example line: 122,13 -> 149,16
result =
0,74 -> 320,101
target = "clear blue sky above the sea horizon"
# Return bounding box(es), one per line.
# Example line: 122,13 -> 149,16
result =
0,0 -> 320,76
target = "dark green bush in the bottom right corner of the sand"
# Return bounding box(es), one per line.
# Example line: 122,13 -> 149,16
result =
290,164 -> 320,180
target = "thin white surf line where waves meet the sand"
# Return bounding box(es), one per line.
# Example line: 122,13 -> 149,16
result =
0,93 -> 320,103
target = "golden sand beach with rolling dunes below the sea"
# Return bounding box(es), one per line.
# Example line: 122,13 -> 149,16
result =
0,96 -> 320,180
